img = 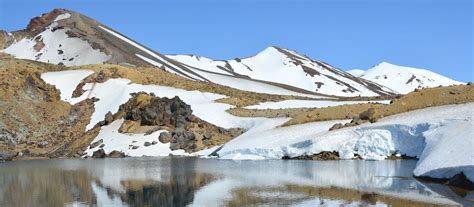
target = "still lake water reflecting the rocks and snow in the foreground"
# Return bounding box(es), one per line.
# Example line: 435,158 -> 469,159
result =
0,158 -> 474,206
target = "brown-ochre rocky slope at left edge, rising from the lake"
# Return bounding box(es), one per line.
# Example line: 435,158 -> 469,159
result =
0,57 -> 95,158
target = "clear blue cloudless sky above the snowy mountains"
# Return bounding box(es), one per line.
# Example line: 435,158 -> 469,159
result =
0,0 -> 474,82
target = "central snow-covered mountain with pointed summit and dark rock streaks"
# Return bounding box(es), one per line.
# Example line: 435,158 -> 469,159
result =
168,47 -> 392,96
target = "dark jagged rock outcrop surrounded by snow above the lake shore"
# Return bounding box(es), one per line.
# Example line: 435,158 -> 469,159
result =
109,92 -> 242,152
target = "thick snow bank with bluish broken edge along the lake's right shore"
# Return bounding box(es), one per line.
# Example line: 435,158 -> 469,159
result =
217,103 -> 474,180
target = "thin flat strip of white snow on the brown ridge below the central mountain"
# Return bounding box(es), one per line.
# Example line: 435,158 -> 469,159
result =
245,100 -> 390,109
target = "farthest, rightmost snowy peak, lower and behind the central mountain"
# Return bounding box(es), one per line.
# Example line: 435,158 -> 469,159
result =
347,62 -> 464,94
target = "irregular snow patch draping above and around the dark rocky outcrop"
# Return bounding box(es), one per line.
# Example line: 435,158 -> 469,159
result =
42,70 -> 266,130
